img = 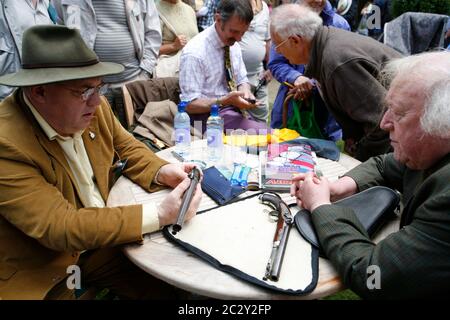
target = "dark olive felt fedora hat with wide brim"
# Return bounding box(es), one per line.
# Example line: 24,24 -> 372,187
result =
0,25 -> 124,87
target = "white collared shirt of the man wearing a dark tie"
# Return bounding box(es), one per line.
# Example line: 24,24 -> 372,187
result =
180,24 -> 248,101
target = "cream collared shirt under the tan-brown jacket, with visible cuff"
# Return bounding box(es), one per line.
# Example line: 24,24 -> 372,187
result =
23,94 -> 160,234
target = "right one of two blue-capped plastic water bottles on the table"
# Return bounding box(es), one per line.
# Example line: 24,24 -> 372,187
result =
206,104 -> 223,162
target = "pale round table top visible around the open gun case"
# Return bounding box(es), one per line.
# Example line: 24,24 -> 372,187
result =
107,142 -> 399,299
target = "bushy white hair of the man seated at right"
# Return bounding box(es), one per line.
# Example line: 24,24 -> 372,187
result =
381,51 -> 450,139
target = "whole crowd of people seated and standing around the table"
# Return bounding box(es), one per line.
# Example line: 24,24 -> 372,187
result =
0,0 -> 450,299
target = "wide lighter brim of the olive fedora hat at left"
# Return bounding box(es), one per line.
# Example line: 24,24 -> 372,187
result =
0,62 -> 124,87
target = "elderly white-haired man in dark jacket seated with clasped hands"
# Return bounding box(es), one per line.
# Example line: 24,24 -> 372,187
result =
291,51 -> 450,299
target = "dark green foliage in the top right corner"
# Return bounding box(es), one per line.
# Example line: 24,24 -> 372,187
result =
391,0 -> 450,18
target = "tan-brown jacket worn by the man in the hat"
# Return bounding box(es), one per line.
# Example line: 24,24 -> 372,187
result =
0,89 -> 167,299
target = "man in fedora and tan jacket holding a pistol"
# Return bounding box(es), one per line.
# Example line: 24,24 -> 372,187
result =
0,25 -> 201,299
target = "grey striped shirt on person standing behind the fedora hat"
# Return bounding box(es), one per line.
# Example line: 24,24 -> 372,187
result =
92,0 -> 141,83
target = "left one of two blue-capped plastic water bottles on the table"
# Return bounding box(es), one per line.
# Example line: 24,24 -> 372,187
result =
174,101 -> 191,159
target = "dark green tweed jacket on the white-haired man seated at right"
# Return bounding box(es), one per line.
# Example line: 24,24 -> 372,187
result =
312,154 -> 450,299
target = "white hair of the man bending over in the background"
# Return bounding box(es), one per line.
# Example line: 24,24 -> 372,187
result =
270,4 -> 323,41
